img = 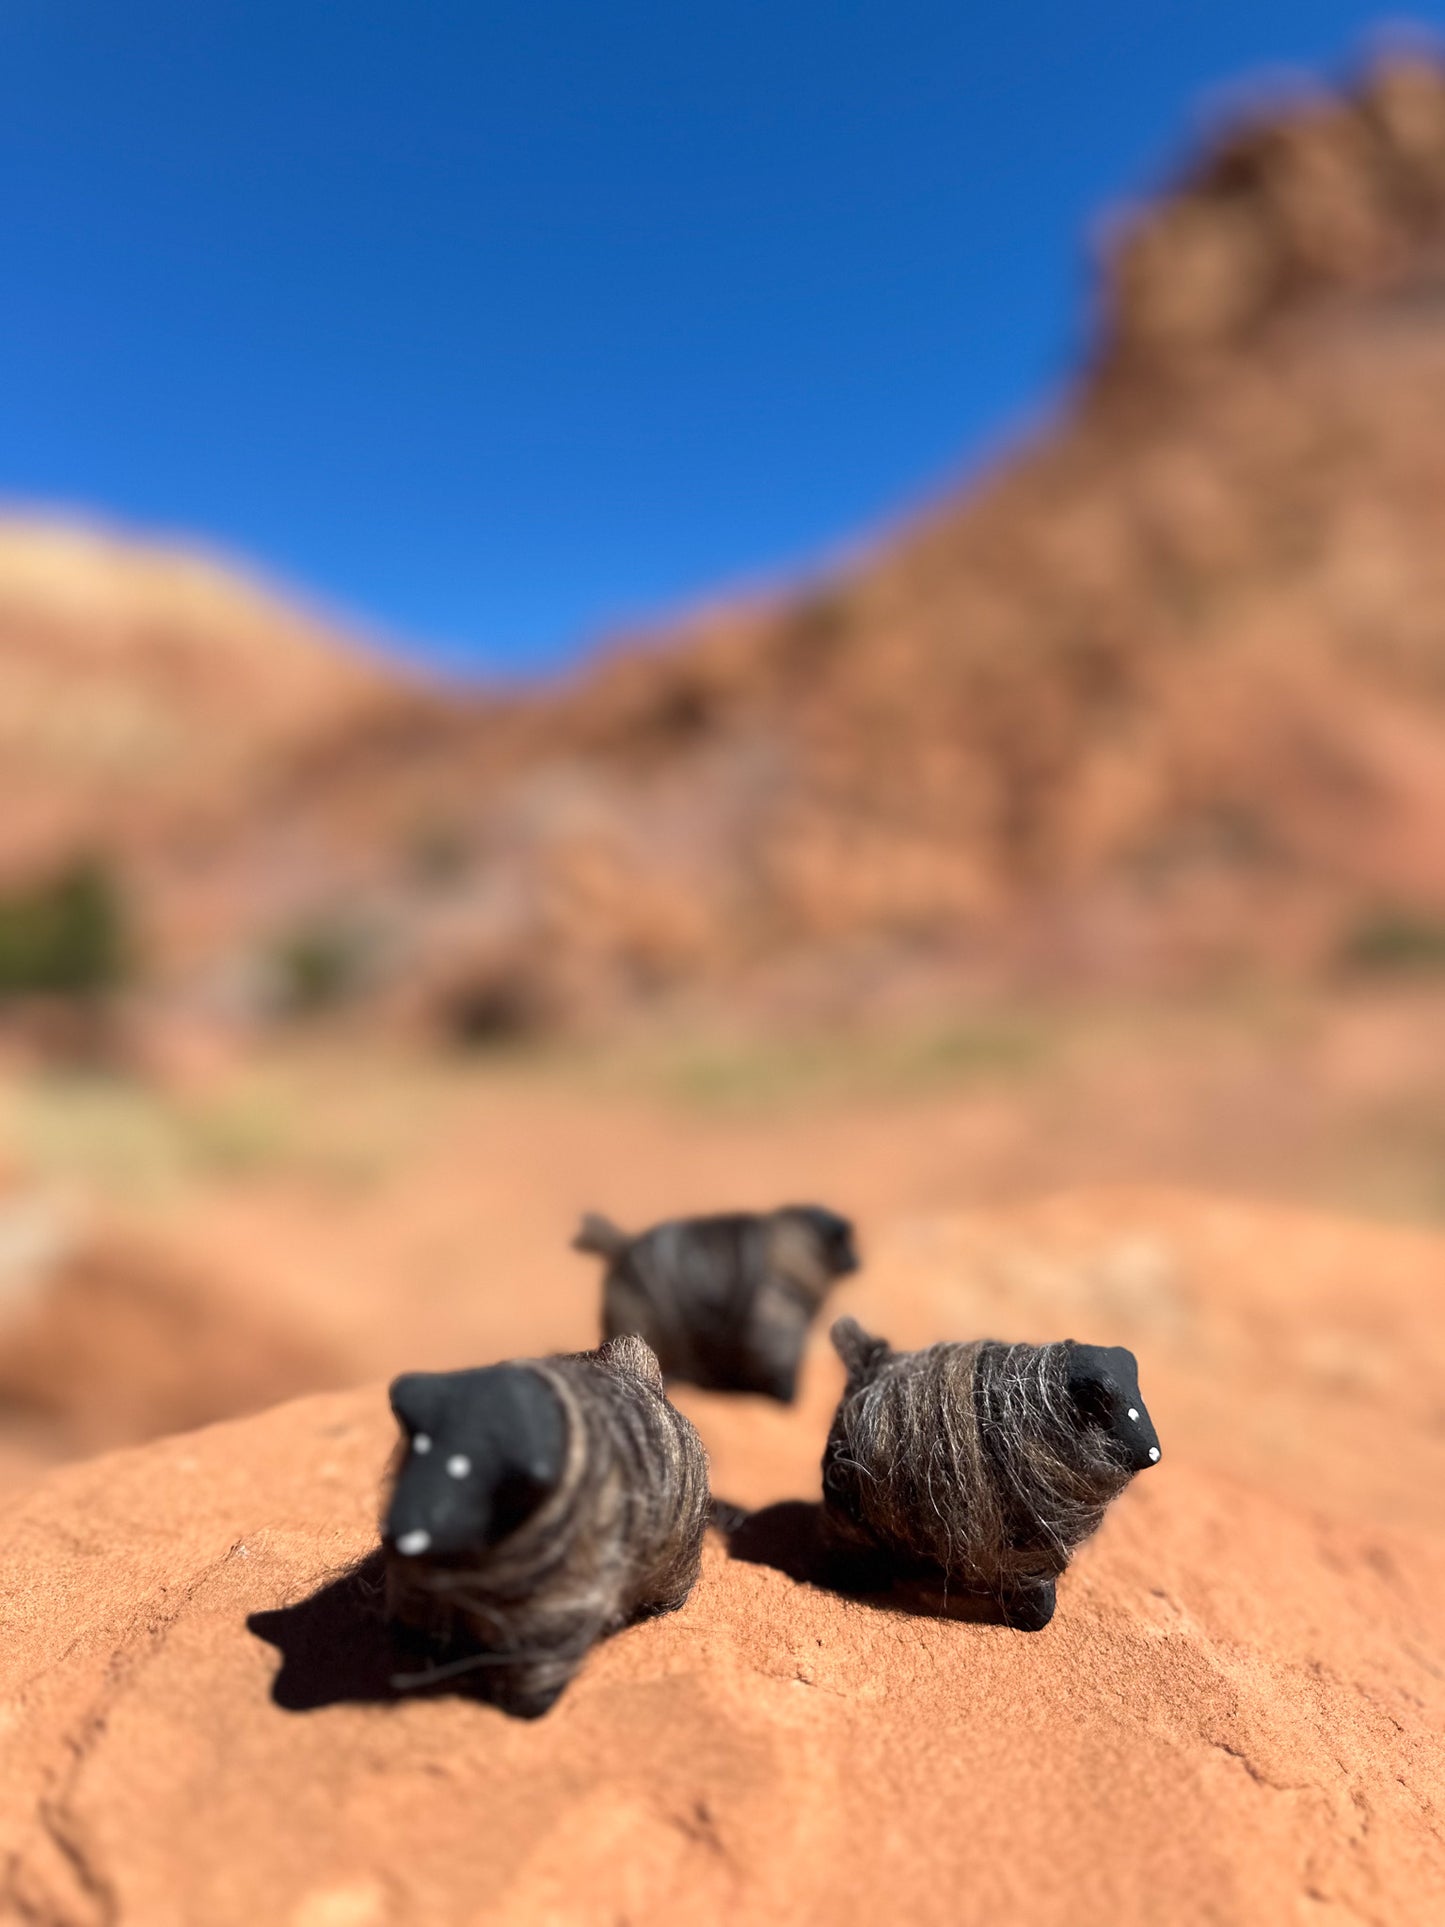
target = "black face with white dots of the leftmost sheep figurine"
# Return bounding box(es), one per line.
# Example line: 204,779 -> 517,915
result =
383,1364 -> 566,1561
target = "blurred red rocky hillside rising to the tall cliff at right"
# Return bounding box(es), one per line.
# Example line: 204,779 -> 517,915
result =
6,60 -> 1445,1033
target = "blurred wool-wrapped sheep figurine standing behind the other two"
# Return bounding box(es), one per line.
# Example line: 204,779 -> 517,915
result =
572,1204 -> 857,1405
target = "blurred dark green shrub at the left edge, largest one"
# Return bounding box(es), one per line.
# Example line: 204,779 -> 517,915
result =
0,858 -> 127,1000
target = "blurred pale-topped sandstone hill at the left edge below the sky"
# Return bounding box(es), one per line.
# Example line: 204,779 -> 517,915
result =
0,520 -> 402,867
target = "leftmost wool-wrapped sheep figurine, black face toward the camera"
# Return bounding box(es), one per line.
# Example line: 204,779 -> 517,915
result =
381,1337 -> 707,1719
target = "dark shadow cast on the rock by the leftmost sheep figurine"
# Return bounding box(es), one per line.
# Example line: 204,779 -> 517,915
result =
247,1549 -> 512,1713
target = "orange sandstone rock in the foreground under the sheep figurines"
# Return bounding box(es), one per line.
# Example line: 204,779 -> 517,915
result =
0,1193 -> 1445,1927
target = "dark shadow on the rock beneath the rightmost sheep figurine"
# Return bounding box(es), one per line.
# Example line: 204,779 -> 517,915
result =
713,1499 -> 1015,1626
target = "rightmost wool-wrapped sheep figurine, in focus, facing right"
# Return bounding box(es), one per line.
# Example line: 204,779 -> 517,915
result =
823,1318 -> 1160,1630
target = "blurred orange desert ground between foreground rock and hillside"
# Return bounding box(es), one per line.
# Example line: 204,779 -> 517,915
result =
0,981 -> 1445,1465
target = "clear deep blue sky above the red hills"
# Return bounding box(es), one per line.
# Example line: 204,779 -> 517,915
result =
0,0 -> 1445,673
